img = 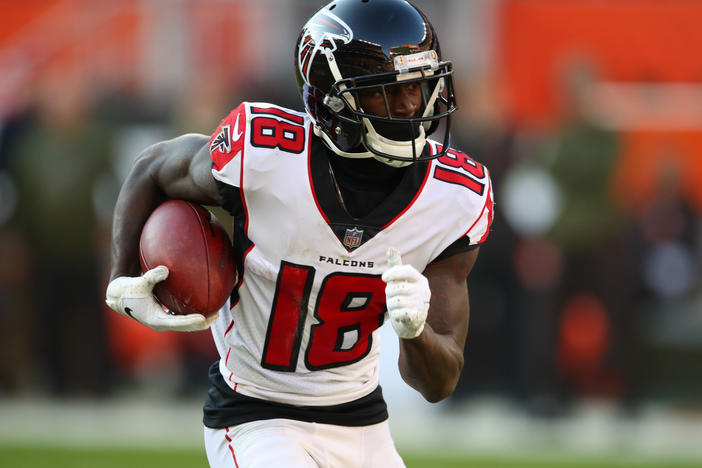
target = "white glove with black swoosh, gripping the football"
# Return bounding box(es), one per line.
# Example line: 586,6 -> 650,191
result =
105,265 -> 218,331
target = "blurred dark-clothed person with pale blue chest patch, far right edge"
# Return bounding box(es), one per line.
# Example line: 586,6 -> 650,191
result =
631,159 -> 702,401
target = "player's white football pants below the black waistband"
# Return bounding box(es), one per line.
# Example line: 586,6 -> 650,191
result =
205,419 -> 405,468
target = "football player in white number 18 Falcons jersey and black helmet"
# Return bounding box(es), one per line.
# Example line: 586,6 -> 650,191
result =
107,0 -> 493,468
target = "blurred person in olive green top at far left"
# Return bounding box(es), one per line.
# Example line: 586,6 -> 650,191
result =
7,73 -> 111,395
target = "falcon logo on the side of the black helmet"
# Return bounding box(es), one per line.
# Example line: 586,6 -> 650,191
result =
297,11 -> 353,83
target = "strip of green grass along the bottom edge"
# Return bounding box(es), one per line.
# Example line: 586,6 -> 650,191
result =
0,446 -> 700,468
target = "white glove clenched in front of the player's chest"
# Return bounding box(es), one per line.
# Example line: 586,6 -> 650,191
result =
382,247 -> 431,339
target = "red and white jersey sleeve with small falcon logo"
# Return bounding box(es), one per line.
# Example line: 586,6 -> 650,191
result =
209,103 -> 248,187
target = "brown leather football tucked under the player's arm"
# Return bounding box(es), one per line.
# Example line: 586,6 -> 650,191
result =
139,200 -> 236,316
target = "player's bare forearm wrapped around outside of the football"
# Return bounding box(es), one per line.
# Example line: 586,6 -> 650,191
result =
110,150 -> 165,279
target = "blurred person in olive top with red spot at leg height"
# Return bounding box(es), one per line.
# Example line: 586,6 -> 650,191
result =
542,58 -> 633,399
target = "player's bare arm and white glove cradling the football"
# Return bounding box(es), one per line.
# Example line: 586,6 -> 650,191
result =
105,134 -> 220,331
